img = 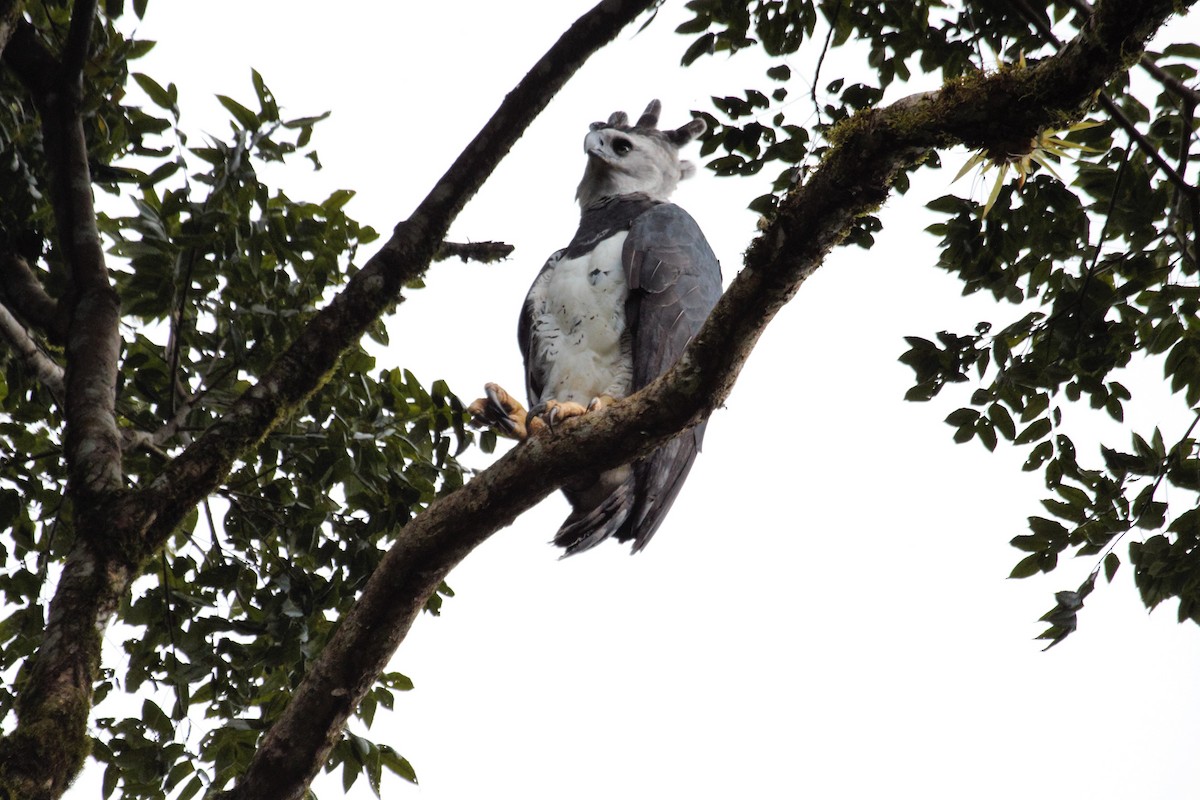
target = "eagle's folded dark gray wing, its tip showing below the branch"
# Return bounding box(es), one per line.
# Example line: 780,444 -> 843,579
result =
617,204 -> 721,552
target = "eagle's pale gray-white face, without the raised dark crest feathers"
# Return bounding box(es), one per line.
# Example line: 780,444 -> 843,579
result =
576,127 -> 690,207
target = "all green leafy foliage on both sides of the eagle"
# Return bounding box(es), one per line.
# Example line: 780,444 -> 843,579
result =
0,0 -> 1200,800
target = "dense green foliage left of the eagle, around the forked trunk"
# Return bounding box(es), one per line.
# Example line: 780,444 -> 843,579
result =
0,4 -> 473,800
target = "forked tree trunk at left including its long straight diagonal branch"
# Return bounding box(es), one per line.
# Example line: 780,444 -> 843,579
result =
0,0 -> 654,796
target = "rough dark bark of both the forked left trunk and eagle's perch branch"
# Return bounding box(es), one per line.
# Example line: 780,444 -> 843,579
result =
0,0 -> 1194,798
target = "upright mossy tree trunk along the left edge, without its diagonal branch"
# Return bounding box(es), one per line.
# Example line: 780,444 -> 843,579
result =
0,7 -> 125,798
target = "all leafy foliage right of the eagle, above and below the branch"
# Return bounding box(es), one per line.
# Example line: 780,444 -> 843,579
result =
679,0 -> 1200,642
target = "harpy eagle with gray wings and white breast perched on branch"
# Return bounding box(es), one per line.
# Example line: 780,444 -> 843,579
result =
469,100 -> 721,555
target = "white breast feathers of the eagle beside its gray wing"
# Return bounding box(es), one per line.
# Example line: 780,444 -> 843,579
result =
530,233 -> 632,405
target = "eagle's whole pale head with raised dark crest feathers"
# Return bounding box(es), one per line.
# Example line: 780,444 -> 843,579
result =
575,100 -> 706,209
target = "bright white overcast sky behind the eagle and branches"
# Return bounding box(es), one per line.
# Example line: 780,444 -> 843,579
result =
71,0 -> 1200,800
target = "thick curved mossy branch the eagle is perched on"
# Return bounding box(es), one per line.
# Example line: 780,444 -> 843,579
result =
216,0 -> 1190,799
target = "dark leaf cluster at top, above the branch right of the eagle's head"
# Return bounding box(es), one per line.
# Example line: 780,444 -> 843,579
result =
677,0 -> 1068,220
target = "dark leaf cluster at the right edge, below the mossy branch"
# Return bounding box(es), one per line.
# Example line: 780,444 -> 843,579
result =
901,21 -> 1200,642
